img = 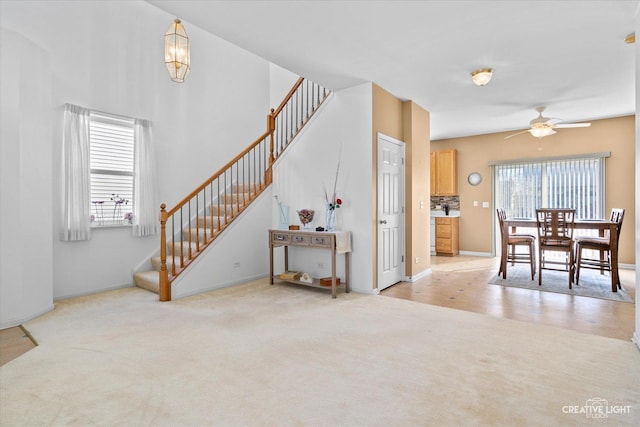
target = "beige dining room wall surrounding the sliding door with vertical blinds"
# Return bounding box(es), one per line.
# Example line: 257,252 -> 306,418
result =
431,116 -> 636,264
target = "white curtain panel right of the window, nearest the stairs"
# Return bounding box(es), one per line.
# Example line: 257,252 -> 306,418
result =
132,119 -> 160,236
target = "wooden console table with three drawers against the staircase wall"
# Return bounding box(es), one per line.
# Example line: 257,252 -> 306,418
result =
269,230 -> 351,298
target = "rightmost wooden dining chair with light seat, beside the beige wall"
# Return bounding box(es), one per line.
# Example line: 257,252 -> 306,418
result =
575,208 -> 624,289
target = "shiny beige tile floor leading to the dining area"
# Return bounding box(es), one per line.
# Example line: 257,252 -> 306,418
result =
381,256 -> 635,340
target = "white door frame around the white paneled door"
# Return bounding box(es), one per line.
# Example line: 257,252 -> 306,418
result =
374,132 -> 407,294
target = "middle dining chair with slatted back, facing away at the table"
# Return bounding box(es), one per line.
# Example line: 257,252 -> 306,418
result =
536,208 -> 576,289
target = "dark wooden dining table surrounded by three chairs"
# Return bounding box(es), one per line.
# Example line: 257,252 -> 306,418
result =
500,218 -> 619,292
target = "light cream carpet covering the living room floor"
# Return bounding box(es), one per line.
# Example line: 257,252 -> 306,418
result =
0,280 -> 640,426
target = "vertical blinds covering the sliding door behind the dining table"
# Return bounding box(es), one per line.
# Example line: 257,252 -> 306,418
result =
494,156 -> 605,219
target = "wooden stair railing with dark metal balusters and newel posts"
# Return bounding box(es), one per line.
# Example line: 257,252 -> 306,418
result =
159,77 -> 330,301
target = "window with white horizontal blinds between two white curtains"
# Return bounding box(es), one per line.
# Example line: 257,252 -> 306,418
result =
89,111 -> 135,226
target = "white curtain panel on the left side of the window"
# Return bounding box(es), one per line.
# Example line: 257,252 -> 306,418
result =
60,104 -> 91,241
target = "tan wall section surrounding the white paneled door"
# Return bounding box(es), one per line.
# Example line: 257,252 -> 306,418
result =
372,84 -> 431,288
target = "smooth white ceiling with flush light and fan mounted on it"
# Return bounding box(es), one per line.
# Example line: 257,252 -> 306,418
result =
148,0 -> 640,140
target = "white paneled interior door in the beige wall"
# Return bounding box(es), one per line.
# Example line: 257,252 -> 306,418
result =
378,133 -> 404,291
